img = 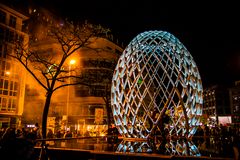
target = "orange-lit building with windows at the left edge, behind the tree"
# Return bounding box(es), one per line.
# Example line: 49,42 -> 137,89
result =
0,3 -> 28,128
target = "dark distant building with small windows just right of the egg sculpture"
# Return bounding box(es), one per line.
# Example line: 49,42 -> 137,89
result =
203,85 -> 231,124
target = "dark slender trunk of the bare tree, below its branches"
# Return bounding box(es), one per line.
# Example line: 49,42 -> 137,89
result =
42,92 -> 52,139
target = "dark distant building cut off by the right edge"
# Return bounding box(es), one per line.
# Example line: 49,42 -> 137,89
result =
229,81 -> 240,123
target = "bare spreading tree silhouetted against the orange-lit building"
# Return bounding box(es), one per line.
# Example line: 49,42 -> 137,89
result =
8,22 -> 109,139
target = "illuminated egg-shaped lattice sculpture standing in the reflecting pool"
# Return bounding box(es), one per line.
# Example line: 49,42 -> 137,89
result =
111,31 -> 203,154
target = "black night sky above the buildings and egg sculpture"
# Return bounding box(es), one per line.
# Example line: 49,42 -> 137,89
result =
3,0 -> 240,87
